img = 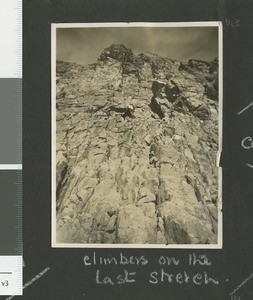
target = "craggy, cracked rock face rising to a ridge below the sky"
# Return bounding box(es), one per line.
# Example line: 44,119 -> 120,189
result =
56,45 -> 218,244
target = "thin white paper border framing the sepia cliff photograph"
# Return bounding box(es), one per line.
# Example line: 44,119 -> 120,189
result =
51,21 -> 223,249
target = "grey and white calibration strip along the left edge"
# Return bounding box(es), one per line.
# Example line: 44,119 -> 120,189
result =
0,0 -> 23,296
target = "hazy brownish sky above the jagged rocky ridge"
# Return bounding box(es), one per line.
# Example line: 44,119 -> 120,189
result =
56,27 -> 218,65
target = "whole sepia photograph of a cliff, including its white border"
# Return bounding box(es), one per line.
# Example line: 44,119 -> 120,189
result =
51,22 -> 222,248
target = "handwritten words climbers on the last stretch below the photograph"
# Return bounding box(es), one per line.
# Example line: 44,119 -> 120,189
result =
83,252 -> 219,286
